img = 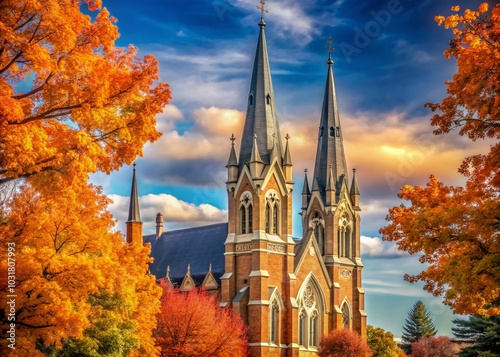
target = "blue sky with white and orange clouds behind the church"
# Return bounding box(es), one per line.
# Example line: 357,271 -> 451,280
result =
92,0 -> 491,336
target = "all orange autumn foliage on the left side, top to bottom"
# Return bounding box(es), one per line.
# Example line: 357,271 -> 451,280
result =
0,0 -> 170,356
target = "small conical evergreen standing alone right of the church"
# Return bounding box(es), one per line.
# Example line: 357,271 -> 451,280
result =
402,300 -> 437,352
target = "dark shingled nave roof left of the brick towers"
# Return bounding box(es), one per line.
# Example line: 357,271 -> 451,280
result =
144,223 -> 227,285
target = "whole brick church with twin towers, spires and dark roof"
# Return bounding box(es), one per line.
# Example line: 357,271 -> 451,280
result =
127,6 -> 366,356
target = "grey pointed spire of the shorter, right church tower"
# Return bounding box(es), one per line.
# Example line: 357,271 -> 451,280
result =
314,39 -> 347,198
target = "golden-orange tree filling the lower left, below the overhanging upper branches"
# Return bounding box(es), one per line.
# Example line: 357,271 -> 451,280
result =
0,179 -> 161,356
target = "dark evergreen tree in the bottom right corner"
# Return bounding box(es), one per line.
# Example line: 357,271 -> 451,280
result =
451,315 -> 500,357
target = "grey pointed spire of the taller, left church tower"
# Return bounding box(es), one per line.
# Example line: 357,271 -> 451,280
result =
238,4 -> 283,169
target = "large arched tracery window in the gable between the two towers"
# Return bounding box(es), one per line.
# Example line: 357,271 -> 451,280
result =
297,275 -> 324,350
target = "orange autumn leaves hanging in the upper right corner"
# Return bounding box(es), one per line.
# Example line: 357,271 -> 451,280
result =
426,3 -> 500,140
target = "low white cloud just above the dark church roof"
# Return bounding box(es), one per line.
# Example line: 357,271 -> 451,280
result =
108,194 -> 227,234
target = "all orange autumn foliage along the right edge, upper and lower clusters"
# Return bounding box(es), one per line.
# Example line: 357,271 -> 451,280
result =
380,3 -> 500,315
